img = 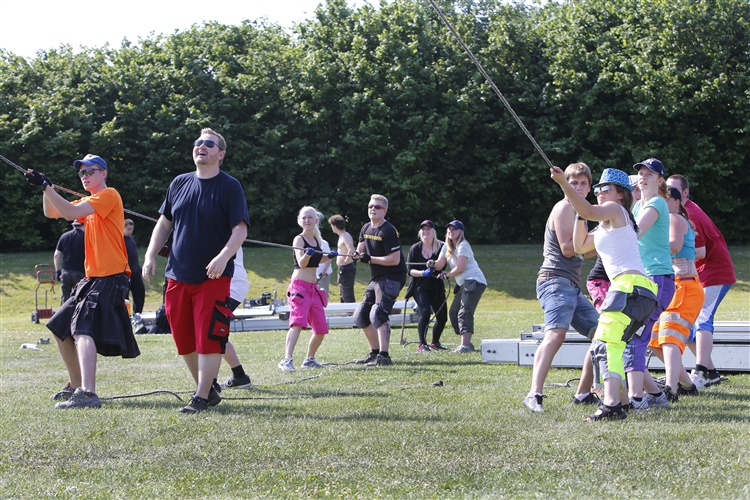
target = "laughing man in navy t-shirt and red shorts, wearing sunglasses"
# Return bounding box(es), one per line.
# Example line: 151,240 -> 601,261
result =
143,128 -> 250,413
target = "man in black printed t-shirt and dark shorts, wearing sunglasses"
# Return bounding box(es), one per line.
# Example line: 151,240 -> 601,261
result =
354,194 -> 406,366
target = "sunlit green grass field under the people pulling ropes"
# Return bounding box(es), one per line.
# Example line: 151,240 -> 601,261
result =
0,245 -> 750,499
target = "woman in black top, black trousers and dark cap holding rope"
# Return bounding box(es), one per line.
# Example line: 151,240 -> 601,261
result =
405,220 -> 448,353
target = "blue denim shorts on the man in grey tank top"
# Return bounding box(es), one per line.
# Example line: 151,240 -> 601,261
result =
536,276 -> 599,339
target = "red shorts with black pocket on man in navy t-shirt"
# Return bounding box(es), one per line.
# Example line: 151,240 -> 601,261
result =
164,276 -> 233,356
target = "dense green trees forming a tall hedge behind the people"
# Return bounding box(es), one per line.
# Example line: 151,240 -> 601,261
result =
0,0 -> 750,251
